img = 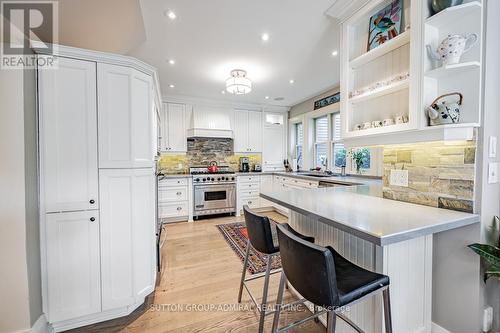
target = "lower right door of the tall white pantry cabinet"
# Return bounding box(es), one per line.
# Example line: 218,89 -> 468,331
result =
99,169 -> 155,310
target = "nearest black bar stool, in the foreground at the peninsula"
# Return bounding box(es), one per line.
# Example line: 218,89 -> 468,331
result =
273,224 -> 392,333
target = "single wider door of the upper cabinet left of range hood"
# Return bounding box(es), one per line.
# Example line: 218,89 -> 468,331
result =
167,103 -> 187,152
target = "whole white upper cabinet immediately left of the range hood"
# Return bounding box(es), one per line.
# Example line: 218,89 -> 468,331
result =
162,103 -> 187,152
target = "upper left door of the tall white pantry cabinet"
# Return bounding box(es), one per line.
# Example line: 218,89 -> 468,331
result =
38,58 -> 98,212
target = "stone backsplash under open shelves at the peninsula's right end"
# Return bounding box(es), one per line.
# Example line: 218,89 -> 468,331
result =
383,141 -> 476,212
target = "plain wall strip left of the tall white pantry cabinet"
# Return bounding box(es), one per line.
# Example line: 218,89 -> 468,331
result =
0,54 -> 42,333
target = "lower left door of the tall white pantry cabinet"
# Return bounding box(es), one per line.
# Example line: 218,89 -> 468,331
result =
45,210 -> 101,322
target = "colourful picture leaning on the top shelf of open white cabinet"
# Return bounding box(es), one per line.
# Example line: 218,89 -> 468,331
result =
367,0 -> 403,51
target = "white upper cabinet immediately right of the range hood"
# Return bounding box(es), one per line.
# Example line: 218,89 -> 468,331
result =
234,110 -> 262,153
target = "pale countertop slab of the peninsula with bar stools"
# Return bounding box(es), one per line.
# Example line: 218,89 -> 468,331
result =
261,186 -> 479,246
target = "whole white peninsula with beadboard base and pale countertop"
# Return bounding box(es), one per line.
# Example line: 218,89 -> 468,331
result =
261,185 -> 480,332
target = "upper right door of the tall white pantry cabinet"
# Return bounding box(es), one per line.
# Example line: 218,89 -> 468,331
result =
97,63 -> 154,168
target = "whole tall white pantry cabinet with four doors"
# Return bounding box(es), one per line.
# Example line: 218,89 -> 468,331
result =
38,46 -> 158,331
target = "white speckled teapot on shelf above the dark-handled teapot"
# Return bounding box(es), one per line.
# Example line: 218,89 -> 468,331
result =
427,34 -> 478,65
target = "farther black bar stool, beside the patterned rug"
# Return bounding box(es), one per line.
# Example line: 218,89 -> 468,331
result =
238,205 -> 314,333
